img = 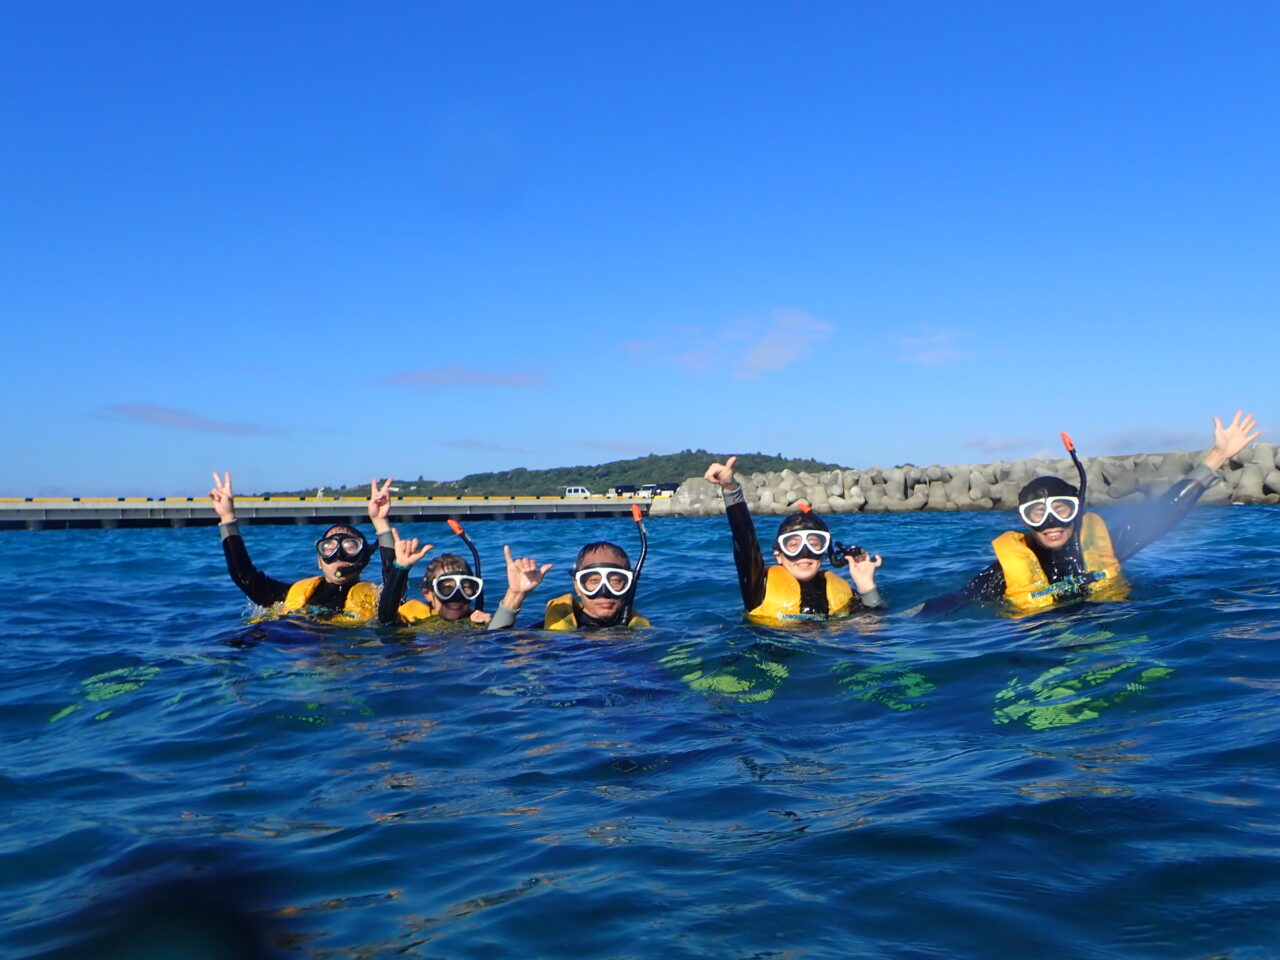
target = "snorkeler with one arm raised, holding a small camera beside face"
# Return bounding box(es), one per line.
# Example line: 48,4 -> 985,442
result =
705,457 -> 884,623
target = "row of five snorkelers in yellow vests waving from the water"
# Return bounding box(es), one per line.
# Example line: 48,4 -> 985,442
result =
210,411 -> 1260,631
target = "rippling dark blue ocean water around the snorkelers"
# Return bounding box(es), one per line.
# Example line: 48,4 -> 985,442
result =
0,507 -> 1280,960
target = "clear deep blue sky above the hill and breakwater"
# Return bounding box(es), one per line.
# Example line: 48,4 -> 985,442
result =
0,1 -> 1280,495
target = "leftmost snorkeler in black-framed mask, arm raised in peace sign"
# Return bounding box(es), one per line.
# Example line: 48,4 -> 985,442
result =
209,471 -> 378,622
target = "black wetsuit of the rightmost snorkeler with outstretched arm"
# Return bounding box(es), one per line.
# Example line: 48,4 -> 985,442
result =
920,465 -> 1217,616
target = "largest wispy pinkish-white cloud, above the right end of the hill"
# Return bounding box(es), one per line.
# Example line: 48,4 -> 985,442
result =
623,308 -> 836,380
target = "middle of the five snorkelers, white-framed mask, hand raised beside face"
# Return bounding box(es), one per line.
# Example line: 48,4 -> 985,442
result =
489,506 -> 650,630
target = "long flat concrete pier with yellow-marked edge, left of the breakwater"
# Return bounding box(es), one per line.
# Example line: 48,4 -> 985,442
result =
0,497 -> 650,530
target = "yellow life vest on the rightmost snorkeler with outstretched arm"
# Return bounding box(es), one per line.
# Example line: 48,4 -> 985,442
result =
991,513 -> 1129,616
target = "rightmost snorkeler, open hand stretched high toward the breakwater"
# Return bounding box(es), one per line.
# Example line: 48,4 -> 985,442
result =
919,411 -> 1260,616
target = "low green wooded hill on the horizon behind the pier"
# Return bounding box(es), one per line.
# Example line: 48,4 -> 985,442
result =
268,451 -> 844,497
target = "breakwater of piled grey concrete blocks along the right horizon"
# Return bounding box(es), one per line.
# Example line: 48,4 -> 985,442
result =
650,443 -> 1280,517
